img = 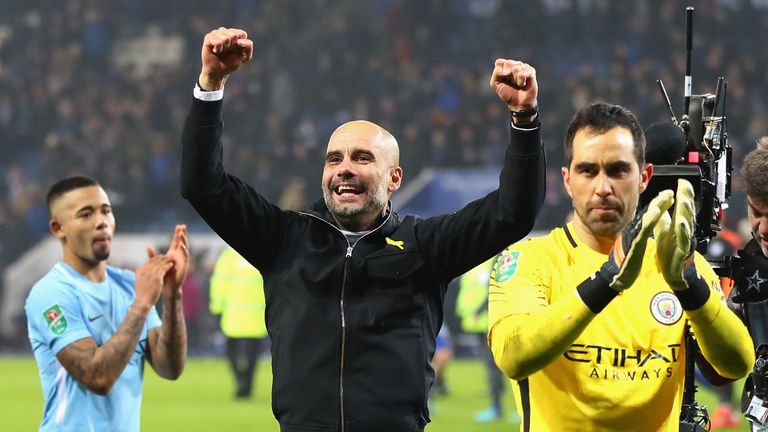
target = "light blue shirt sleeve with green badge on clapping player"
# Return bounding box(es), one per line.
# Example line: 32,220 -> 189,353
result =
25,283 -> 92,355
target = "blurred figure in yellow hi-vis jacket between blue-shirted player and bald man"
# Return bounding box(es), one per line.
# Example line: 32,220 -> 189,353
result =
210,246 -> 267,399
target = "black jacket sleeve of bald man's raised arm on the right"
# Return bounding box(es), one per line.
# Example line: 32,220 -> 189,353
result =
416,119 -> 546,280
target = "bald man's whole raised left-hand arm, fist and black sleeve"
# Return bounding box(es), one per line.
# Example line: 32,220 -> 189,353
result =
181,27 -> 283,268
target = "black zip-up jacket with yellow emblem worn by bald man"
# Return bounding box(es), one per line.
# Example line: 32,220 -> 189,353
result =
181,99 -> 545,432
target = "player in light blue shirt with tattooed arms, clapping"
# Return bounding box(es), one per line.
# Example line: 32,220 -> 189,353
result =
24,177 -> 189,431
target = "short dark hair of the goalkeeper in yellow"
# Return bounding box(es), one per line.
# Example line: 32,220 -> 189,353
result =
564,102 -> 645,167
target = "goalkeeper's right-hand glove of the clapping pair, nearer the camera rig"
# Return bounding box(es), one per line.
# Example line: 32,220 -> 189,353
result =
653,179 -> 697,291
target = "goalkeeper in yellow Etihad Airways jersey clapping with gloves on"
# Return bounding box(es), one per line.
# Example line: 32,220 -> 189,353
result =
488,103 -> 754,432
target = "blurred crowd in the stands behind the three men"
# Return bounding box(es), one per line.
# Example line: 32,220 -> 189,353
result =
0,0 -> 768,344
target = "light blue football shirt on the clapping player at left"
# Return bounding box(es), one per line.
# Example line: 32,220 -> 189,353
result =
24,262 -> 161,432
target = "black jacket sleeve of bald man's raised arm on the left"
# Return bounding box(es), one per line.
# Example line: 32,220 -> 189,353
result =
181,99 -> 284,269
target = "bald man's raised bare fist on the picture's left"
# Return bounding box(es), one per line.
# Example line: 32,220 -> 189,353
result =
198,27 -> 253,91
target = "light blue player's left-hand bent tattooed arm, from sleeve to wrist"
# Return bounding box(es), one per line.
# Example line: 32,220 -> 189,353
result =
56,308 -> 146,395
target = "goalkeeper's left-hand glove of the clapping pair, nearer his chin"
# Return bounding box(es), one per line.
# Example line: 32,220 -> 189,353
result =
599,190 -> 673,291
